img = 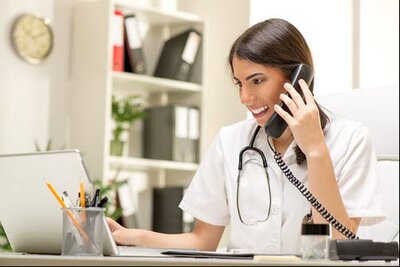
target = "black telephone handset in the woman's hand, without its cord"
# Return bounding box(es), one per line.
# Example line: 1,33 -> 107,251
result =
264,64 -> 314,138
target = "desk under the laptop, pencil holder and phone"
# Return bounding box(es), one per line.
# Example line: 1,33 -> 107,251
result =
0,253 -> 399,266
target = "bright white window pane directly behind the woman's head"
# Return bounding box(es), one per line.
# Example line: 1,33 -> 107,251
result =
250,0 -> 352,94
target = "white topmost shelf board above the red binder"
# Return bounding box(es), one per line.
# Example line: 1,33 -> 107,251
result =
115,0 -> 203,25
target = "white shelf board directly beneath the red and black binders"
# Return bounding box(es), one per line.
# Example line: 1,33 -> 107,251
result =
112,72 -> 202,93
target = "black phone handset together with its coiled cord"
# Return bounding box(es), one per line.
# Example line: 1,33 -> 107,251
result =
265,64 -> 358,239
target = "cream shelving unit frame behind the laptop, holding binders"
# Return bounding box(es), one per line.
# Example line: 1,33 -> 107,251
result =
71,0 -> 204,184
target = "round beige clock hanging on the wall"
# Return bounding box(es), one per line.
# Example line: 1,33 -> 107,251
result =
11,14 -> 53,64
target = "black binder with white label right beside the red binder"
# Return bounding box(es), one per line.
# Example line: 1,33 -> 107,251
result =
124,15 -> 147,74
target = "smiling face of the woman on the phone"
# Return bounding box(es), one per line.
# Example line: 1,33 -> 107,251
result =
232,56 -> 288,126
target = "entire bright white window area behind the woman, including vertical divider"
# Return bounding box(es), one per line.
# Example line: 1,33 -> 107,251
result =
250,0 -> 399,95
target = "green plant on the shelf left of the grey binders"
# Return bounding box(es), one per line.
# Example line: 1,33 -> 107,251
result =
111,95 -> 147,143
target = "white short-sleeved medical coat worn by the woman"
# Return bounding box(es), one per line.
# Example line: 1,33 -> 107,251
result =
179,118 -> 385,254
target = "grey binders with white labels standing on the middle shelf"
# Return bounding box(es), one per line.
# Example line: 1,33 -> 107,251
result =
143,105 -> 200,162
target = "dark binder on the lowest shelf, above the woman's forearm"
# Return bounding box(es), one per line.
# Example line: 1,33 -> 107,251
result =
153,186 -> 183,234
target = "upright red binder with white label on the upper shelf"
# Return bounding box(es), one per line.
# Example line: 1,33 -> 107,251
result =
112,10 -> 124,71
